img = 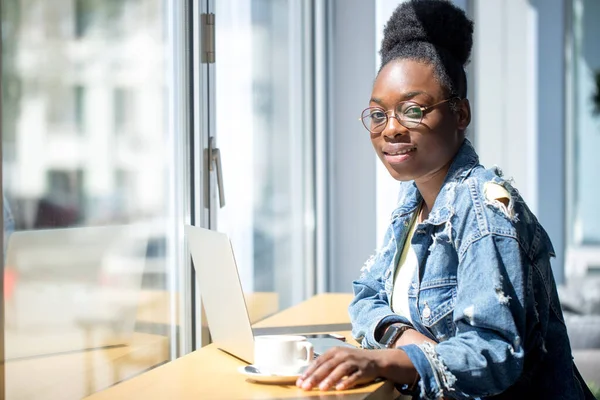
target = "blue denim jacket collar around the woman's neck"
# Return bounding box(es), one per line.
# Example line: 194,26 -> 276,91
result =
392,139 -> 479,225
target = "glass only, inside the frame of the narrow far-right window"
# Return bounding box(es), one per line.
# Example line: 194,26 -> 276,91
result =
569,0 -> 600,247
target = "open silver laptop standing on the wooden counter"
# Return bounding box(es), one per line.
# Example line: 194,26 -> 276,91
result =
185,225 -> 354,364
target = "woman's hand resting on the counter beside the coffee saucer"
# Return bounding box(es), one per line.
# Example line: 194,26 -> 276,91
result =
296,347 -> 383,390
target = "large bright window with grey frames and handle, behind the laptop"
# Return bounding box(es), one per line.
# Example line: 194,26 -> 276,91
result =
2,0 -> 314,398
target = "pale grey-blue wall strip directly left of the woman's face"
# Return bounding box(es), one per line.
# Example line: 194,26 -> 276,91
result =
328,0 -> 375,292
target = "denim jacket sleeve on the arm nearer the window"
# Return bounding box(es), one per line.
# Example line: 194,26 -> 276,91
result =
348,226 -> 409,349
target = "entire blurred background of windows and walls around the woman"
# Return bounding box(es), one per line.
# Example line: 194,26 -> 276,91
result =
1,0 -> 600,399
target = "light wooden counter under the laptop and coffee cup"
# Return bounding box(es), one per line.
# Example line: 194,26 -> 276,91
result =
83,294 -> 394,400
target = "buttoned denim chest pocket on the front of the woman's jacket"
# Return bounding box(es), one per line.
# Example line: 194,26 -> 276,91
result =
418,280 -> 456,341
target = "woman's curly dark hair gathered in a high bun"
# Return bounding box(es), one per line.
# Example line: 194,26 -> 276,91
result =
380,0 -> 473,98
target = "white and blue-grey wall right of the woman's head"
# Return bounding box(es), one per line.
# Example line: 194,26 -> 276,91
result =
471,0 -> 566,282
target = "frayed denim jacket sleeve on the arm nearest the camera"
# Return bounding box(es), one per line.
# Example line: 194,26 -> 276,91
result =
402,234 -> 530,399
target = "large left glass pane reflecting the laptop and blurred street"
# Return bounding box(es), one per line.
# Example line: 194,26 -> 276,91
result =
2,0 -> 182,399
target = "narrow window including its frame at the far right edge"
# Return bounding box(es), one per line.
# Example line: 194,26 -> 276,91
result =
565,0 -> 600,276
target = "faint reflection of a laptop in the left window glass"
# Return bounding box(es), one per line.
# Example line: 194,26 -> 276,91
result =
4,225 -> 148,360
